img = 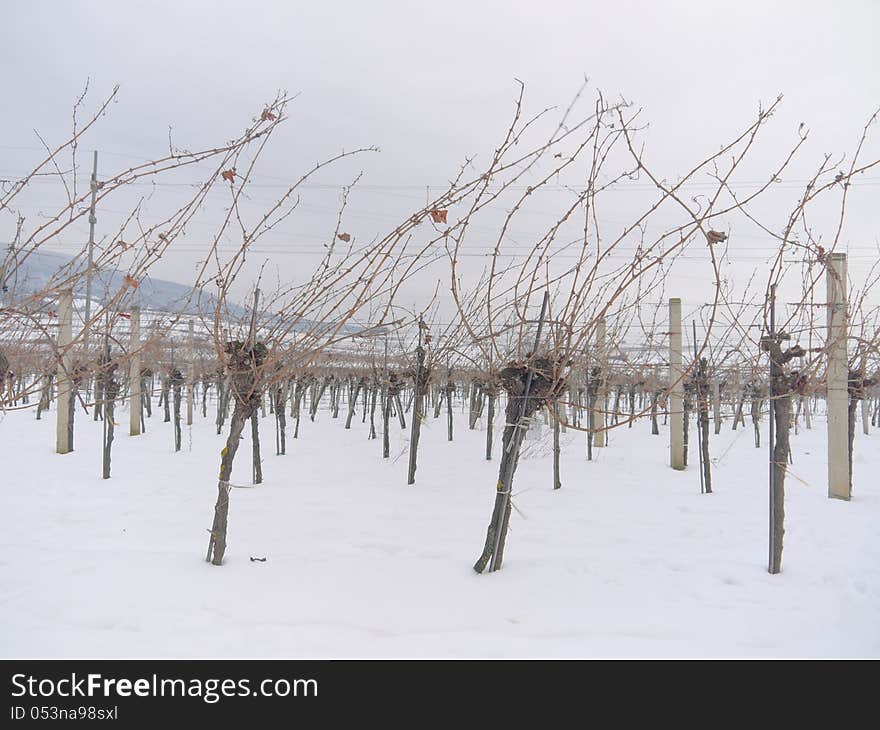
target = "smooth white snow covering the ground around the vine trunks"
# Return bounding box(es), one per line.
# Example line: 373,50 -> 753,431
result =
0,396 -> 880,658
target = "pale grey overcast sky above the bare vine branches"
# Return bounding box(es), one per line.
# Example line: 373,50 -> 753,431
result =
0,0 -> 880,324
